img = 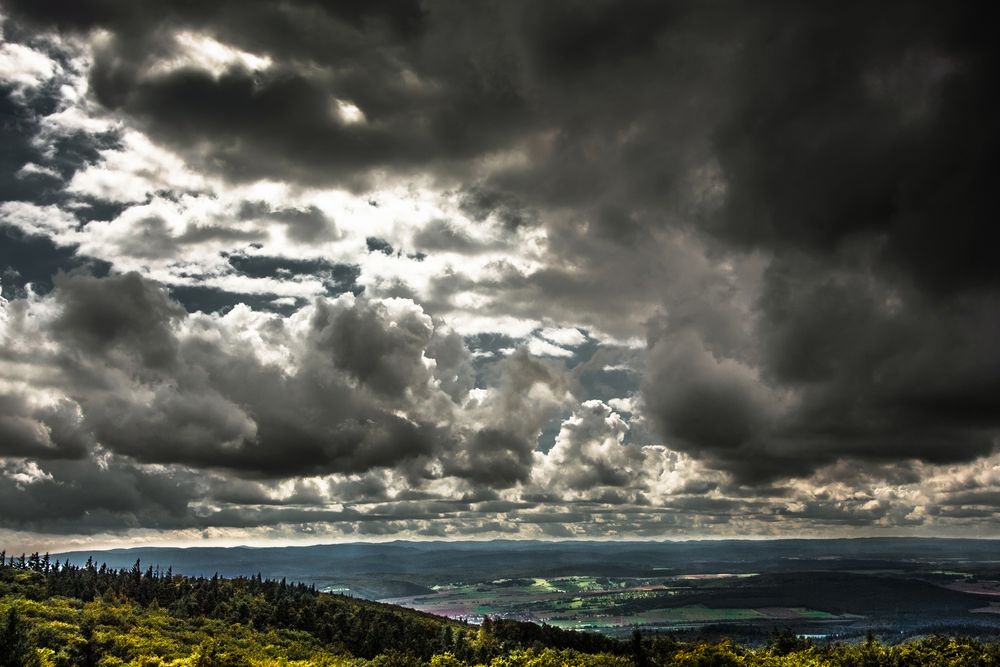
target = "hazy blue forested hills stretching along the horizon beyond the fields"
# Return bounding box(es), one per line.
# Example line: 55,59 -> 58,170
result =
52,538 -> 1000,597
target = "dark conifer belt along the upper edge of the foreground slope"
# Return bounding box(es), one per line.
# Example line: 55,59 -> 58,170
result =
0,552 -> 625,662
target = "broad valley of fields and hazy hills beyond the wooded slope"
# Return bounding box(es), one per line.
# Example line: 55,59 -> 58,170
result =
57,539 -> 1000,643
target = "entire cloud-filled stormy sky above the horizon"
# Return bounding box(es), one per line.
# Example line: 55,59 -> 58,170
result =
0,0 -> 1000,551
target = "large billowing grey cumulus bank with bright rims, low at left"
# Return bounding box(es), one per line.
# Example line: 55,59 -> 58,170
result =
0,274 -> 584,525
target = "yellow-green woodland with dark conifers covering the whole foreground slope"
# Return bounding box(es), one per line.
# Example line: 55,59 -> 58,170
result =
0,554 -> 1000,667
